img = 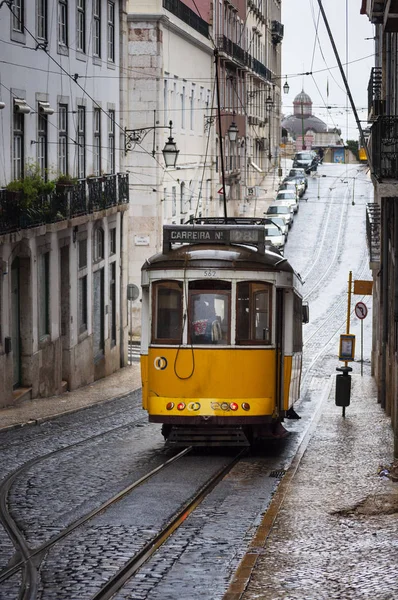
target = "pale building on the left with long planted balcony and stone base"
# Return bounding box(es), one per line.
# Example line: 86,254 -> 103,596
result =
0,0 -> 128,406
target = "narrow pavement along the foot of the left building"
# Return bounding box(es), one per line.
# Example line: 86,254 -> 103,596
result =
0,362 -> 141,431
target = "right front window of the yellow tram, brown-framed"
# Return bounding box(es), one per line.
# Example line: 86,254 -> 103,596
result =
236,281 -> 272,344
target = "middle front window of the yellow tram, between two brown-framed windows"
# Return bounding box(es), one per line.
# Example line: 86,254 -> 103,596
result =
189,282 -> 231,344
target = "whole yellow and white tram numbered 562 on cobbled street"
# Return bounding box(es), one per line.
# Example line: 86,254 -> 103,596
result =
141,219 -> 303,445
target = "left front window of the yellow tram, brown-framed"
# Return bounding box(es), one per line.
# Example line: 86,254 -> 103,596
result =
152,281 -> 182,344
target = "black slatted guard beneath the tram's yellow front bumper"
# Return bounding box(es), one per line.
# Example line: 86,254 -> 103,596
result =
166,427 -> 250,447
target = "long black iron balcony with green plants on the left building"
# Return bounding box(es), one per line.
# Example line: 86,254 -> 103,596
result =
0,173 -> 129,235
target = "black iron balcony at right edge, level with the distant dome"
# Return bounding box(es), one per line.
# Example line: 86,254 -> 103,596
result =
371,117 -> 398,181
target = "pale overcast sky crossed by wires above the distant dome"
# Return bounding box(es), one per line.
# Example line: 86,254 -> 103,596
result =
282,0 -> 374,140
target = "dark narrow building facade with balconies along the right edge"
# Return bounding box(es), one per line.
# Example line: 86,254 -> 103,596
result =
361,0 -> 398,458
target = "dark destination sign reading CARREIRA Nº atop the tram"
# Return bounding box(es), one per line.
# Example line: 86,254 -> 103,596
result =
163,225 -> 265,251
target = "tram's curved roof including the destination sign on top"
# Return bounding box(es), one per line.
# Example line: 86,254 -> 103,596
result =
142,223 -> 294,273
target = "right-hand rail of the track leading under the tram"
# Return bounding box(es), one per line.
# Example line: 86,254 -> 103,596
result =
91,448 -> 247,600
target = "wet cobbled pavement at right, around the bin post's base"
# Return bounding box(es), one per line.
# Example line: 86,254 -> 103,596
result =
224,375 -> 398,600
